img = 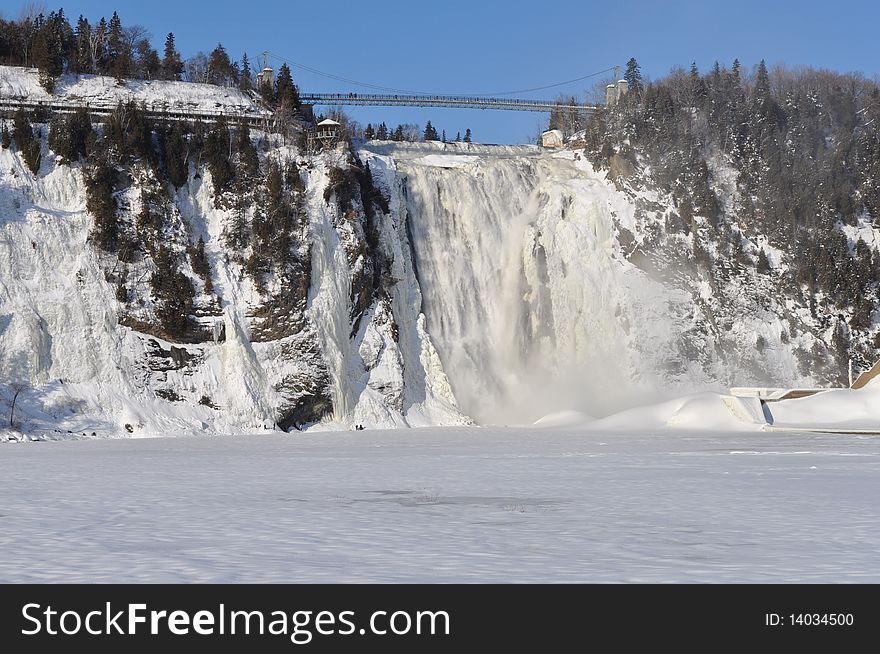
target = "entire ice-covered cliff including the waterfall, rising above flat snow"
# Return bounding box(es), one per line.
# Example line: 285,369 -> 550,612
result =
0,114 -> 864,436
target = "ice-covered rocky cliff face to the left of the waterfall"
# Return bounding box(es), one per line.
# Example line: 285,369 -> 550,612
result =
0,135 -> 468,437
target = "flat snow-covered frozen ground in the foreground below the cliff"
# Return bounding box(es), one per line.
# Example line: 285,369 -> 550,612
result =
0,427 -> 880,582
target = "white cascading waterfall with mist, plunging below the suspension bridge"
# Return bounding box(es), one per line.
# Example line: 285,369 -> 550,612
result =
368,144 -> 687,424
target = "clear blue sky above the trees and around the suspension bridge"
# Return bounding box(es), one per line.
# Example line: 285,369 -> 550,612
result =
6,0 -> 880,143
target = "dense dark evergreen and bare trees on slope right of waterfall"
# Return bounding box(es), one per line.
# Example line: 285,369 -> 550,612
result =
584,59 -> 880,380
